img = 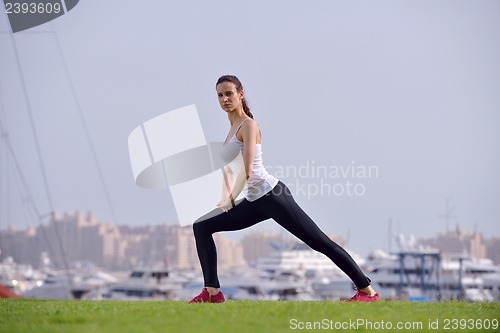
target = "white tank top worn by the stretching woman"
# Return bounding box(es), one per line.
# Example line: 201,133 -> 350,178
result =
220,118 -> 279,201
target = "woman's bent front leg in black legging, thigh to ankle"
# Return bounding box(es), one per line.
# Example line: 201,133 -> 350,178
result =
193,199 -> 268,288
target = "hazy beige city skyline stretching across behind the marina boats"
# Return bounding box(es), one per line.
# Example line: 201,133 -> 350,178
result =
0,211 -> 500,270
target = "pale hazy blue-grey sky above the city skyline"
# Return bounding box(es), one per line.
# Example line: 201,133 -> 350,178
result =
0,0 -> 500,254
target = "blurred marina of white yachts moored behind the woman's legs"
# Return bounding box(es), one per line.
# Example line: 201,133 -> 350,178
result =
0,233 -> 500,302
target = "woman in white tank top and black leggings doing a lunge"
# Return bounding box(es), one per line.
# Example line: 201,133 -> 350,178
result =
190,75 -> 379,303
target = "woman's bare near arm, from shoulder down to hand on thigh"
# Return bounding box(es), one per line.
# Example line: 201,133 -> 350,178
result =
217,120 -> 259,212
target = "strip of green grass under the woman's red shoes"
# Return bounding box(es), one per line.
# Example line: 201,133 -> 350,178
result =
0,299 -> 500,333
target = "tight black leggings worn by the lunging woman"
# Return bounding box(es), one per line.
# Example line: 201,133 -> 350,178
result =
193,181 -> 370,289
